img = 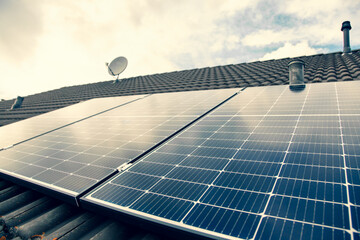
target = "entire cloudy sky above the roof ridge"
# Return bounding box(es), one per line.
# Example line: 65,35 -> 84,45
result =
0,0 -> 360,99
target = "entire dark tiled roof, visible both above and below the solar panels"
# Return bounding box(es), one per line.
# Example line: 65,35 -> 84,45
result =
0,50 -> 360,239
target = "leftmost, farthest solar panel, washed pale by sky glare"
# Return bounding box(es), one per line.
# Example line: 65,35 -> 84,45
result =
0,95 -> 144,150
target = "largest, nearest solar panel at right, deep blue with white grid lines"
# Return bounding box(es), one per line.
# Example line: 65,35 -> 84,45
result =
82,82 -> 360,239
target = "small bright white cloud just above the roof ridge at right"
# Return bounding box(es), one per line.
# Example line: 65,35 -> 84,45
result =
259,41 -> 326,61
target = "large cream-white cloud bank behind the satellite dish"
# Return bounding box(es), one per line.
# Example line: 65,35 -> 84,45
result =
0,0 -> 256,98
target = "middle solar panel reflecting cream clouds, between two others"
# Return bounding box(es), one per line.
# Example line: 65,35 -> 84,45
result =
0,89 -> 239,202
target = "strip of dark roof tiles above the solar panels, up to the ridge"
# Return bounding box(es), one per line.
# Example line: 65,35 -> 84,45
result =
0,50 -> 360,126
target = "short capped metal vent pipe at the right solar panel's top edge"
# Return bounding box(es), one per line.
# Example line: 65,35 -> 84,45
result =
289,59 -> 305,90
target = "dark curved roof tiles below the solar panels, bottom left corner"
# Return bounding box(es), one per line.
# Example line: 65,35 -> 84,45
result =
0,180 -> 164,240
